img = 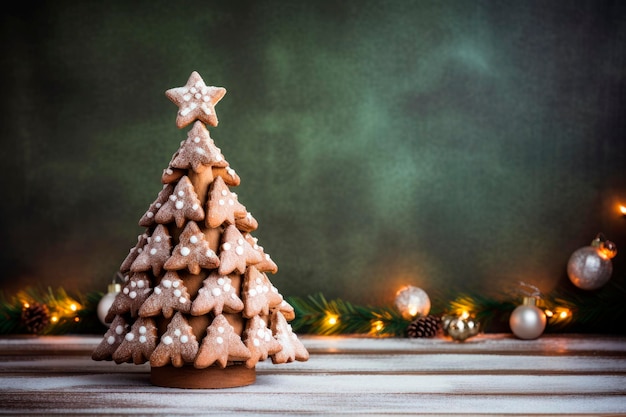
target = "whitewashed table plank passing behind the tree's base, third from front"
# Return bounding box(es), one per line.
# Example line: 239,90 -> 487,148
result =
0,354 -> 626,374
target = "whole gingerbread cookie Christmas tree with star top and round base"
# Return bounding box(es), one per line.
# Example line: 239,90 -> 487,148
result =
92,72 -> 309,388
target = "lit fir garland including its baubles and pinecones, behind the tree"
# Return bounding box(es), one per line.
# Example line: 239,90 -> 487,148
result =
0,205 -> 626,341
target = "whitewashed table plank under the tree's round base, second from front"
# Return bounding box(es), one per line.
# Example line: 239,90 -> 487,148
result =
0,374 -> 626,394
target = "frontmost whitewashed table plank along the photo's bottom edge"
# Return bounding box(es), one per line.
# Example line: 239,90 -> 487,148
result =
0,381 -> 626,416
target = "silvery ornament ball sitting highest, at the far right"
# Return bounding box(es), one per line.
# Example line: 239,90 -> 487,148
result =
567,246 -> 613,290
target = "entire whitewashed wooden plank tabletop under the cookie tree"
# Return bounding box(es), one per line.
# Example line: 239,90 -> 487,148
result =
0,334 -> 626,416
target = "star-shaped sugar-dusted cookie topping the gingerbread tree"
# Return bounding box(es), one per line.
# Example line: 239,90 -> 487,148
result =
165,71 -> 226,128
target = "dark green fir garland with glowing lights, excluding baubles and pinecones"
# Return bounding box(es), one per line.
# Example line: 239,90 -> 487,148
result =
0,279 -> 626,337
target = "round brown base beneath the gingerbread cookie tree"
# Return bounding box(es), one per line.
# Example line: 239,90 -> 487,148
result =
150,365 -> 256,388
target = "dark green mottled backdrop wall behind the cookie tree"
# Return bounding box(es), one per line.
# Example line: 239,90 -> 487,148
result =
0,0 -> 626,304
